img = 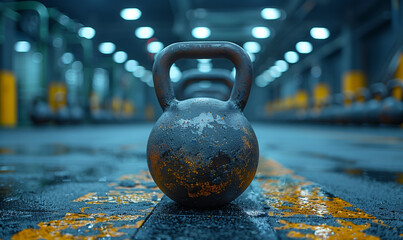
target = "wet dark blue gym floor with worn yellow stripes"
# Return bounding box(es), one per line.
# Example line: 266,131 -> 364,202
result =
0,124 -> 403,239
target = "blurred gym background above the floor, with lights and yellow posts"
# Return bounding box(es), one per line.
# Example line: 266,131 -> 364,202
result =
0,0 -> 403,127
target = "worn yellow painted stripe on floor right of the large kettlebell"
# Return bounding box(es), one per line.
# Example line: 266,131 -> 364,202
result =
257,159 -> 390,239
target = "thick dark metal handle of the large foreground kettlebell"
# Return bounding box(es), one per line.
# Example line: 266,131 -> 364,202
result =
153,41 -> 253,111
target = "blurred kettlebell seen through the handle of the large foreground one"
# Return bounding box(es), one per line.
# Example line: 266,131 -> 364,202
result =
175,69 -> 234,101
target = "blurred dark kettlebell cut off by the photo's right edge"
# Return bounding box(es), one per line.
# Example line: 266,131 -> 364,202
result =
381,79 -> 403,125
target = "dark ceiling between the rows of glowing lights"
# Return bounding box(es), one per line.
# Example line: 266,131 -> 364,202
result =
14,0 -> 389,74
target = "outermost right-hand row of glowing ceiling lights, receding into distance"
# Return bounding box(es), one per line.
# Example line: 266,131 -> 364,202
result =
256,27 -> 330,87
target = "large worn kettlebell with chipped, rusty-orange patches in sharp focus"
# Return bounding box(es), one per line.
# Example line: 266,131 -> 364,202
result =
147,41 -> 259,208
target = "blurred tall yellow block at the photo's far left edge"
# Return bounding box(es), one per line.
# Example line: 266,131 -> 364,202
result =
0,70 -> 17,127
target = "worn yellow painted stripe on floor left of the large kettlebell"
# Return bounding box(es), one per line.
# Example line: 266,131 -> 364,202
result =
11,171 -> 162,240
